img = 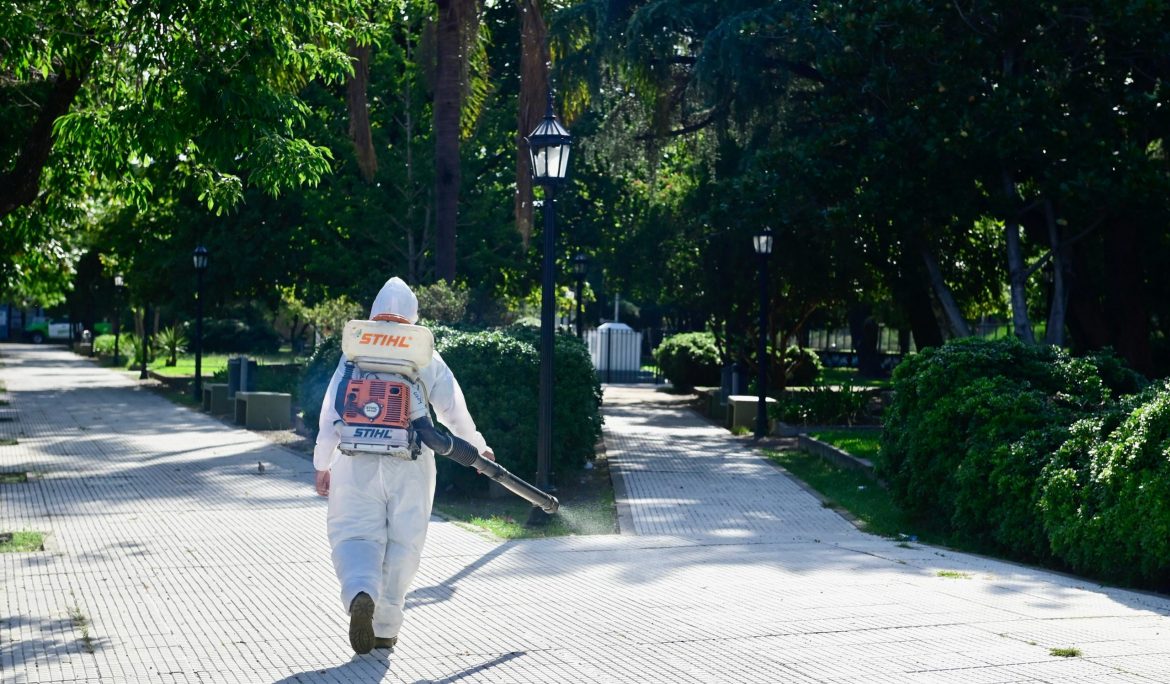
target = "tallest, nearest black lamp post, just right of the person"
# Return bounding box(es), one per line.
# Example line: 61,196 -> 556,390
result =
528,89 -> 572,525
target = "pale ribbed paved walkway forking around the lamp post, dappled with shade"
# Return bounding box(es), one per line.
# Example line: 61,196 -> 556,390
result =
0,345 -> 1170,684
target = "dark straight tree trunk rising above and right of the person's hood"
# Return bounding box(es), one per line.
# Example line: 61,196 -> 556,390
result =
434,0 -> 475,283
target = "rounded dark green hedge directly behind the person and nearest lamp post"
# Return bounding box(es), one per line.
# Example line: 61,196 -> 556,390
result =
301,325 -> 601,491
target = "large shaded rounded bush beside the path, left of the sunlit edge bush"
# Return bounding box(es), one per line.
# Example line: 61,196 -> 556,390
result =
876,338 -> 1109,559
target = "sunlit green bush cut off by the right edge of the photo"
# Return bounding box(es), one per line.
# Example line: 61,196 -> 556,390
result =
1039,384 -> 1170,592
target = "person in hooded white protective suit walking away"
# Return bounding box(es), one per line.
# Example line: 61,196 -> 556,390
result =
312,277 -> 495,654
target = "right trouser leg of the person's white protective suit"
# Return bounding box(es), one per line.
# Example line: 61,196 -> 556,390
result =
373,449 -> 435,637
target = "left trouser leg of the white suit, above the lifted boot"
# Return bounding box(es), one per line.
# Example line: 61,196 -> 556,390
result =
328,455 -> 386,610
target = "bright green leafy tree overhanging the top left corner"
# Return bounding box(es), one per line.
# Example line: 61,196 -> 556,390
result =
0,0 -> 365,301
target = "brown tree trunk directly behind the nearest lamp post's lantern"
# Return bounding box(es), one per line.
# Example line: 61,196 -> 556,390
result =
512,0 -> 549,248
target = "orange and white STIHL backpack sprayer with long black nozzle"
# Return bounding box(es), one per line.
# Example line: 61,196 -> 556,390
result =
333,315 -> 560,513
